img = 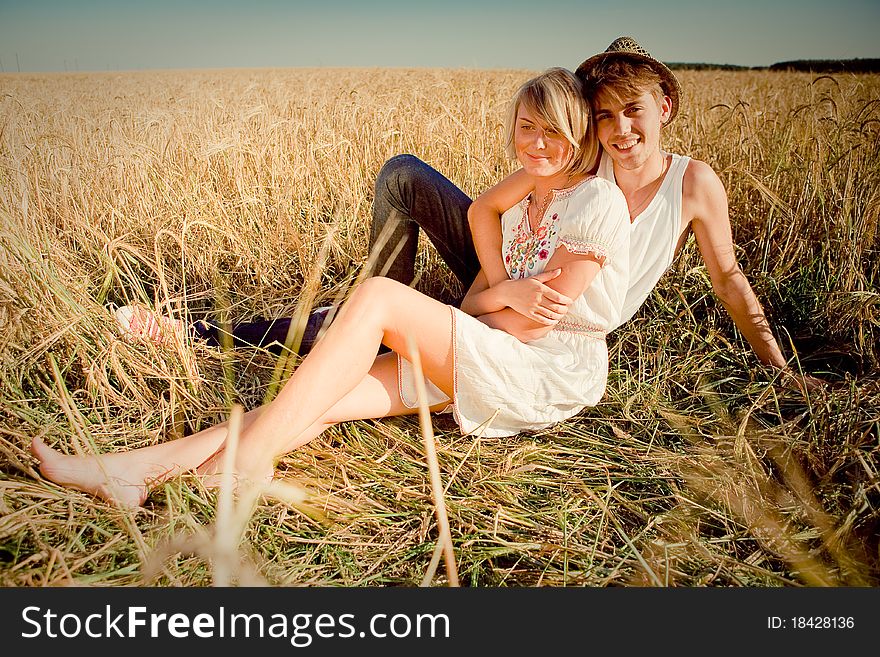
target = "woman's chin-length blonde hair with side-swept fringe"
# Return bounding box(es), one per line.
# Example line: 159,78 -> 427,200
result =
505,67 -> 599,174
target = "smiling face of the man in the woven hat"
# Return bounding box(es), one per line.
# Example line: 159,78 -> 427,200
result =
594,86 -> 672,170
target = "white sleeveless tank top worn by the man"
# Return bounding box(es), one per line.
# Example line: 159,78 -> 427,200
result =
597,152 -> 691,328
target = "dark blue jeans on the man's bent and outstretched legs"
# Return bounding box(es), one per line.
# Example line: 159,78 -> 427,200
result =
192,155 -> 480,355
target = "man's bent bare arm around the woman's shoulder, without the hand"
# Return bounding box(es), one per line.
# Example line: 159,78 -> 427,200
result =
468,169 -> 534,287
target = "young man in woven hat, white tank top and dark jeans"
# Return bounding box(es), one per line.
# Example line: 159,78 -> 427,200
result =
122,37 -> 818,387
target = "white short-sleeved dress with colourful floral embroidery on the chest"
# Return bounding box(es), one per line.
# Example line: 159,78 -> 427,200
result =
398,176 -> 630,437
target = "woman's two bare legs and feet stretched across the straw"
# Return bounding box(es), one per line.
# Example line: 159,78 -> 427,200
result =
31,279 -> 453,506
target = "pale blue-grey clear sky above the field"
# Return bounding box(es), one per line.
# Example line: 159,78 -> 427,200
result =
0,0 -> 880,72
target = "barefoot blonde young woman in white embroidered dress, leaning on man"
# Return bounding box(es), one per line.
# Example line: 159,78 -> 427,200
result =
31,68 -> 629,506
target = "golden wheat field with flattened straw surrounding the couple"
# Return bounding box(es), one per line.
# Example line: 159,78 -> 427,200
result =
0,69 -> 880,587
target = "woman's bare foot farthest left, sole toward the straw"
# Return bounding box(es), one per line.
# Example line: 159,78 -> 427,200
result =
31,438 -> 149,508
